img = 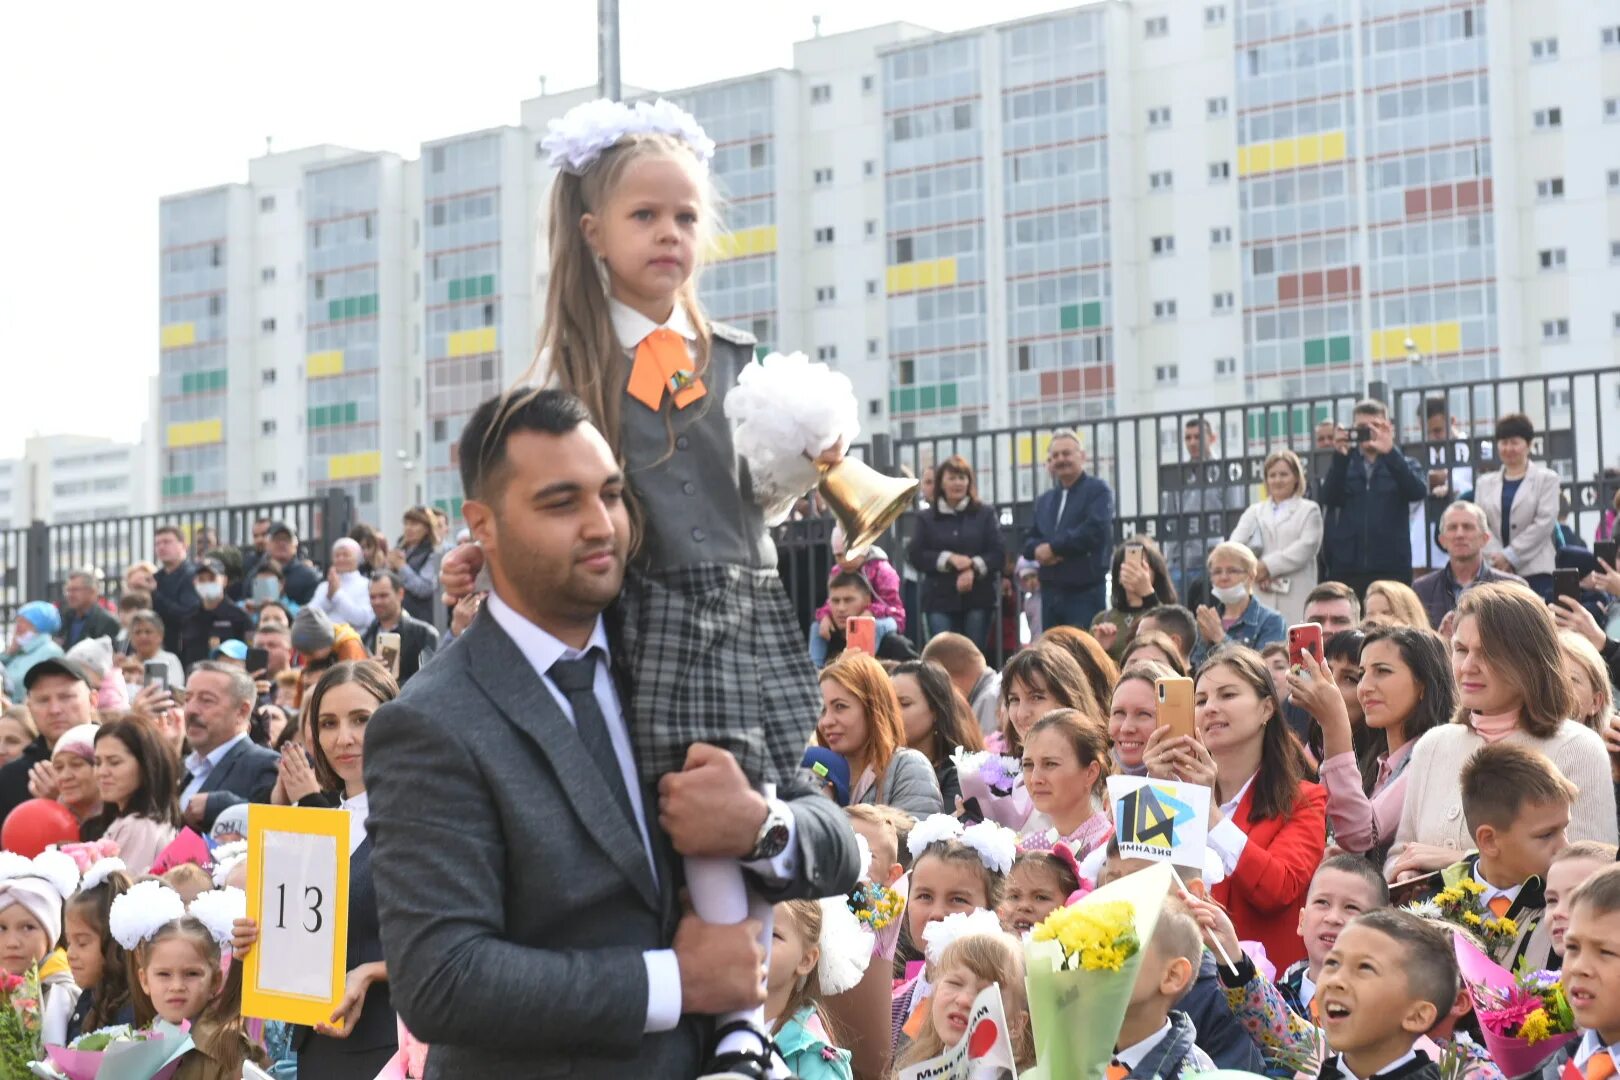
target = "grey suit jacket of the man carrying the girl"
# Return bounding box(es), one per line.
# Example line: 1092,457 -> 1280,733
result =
365,615 -> 859,1080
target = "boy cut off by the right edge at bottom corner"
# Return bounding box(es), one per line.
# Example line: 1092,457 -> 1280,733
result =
1526,866 -> 1620,1080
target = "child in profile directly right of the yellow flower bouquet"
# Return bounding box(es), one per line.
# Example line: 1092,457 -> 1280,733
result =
1108,895 -> 1215,1080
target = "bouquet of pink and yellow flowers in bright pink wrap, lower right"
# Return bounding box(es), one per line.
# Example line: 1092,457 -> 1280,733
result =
1452,934 -> 1578,1077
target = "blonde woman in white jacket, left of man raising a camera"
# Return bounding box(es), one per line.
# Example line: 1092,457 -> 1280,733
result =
1230,450 -> 1322,625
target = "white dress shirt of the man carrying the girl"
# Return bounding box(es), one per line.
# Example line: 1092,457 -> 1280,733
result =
484,595 -> 799,1033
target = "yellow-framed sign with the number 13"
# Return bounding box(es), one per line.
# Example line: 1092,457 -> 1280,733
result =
241,803 -> 350,1027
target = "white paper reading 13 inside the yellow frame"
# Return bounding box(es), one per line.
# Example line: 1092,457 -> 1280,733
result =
258,829 -> 348,1001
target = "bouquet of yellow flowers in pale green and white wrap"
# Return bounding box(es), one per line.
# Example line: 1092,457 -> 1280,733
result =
1024,863 -> 1175,1080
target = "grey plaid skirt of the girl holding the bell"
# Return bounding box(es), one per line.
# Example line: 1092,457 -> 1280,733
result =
619,563 -> 821,785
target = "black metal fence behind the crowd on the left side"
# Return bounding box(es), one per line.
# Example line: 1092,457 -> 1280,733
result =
0,489 -> 355,625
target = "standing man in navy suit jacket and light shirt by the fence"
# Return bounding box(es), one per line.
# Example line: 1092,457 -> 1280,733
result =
1024,431 -> 1113,630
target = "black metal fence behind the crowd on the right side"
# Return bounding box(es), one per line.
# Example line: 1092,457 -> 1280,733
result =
778,369 -> 1620,660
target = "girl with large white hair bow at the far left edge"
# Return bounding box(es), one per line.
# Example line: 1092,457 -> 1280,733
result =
0,848 -> 79,1043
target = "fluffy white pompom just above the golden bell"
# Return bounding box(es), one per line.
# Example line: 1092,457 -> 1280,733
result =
726,353 -> 860,525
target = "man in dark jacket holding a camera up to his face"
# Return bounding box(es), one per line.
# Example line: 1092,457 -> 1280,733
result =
1320,400 -> 1429,597
